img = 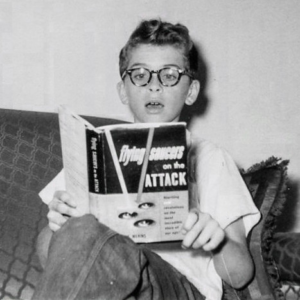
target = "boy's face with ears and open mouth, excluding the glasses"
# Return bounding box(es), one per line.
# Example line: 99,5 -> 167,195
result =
118,45 -> 200,123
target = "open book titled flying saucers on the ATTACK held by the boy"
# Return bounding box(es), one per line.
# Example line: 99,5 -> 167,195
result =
59,106 -> 189,243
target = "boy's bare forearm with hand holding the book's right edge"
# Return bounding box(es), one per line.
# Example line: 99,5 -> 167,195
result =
182,209 -> 254,289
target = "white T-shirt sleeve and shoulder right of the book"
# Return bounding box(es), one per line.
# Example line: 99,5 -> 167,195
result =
192,140 -> 260,235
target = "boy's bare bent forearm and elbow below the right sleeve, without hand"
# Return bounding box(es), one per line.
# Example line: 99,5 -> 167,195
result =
213,219 -> 254,289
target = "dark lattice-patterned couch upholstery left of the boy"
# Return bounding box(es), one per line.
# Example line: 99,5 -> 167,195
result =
0,110 -> 62,299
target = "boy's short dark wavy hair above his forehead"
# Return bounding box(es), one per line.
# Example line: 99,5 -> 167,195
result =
119,19 -> 198,76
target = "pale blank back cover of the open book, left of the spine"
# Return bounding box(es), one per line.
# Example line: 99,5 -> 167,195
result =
59,106 -> 92,215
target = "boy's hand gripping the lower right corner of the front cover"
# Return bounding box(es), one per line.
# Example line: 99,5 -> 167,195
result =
182,209 -> 225,251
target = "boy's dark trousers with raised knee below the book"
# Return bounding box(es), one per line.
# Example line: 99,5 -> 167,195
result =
32,215 -> 205,300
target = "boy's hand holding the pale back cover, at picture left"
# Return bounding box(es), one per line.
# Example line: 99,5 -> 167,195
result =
47,191 -> 79,231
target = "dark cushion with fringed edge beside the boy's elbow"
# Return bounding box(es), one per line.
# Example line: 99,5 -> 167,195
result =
223,157 -> 288,300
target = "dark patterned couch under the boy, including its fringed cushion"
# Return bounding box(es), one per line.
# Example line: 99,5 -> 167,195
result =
0,109 -> 300,300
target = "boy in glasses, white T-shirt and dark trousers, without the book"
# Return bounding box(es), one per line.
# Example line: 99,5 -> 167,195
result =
34,20 -> 259,300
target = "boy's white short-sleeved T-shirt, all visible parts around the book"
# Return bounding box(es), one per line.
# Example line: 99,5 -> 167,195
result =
40,140 -> 260,300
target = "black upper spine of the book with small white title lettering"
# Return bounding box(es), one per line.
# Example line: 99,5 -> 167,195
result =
86,129 -> 106,194
